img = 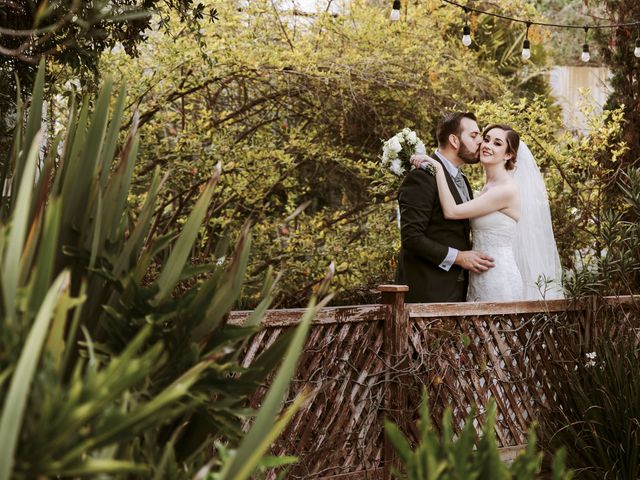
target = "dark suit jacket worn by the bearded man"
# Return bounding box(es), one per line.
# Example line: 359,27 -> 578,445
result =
396,154 -> 473,303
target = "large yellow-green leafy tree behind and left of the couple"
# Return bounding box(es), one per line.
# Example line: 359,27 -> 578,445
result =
94,1 -> 556,305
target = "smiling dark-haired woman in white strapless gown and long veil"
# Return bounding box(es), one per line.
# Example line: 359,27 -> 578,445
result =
412,124 -> 564,302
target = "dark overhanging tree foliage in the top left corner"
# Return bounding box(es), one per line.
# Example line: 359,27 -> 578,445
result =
0,0 -> 217,156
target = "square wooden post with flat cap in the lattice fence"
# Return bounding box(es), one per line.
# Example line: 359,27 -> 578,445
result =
378,285 -> 410,480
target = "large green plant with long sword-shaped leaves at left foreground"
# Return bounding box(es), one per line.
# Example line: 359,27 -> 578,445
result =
0,65 -> 322,480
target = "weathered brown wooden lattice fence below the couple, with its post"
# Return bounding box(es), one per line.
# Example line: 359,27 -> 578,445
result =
229,285 -> 637,478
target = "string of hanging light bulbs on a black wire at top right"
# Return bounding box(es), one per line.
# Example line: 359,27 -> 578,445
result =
391,0 -> 640,63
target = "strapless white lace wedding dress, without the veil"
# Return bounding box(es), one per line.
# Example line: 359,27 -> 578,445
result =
467,212 -> 523,302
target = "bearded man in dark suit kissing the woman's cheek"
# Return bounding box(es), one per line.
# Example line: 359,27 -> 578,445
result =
396,112 -> 494,303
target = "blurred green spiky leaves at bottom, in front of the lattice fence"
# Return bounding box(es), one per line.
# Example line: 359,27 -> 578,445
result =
385,392 -> 573,480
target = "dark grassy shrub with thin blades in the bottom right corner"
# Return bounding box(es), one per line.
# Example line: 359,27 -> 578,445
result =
541,330 -> 640,480
